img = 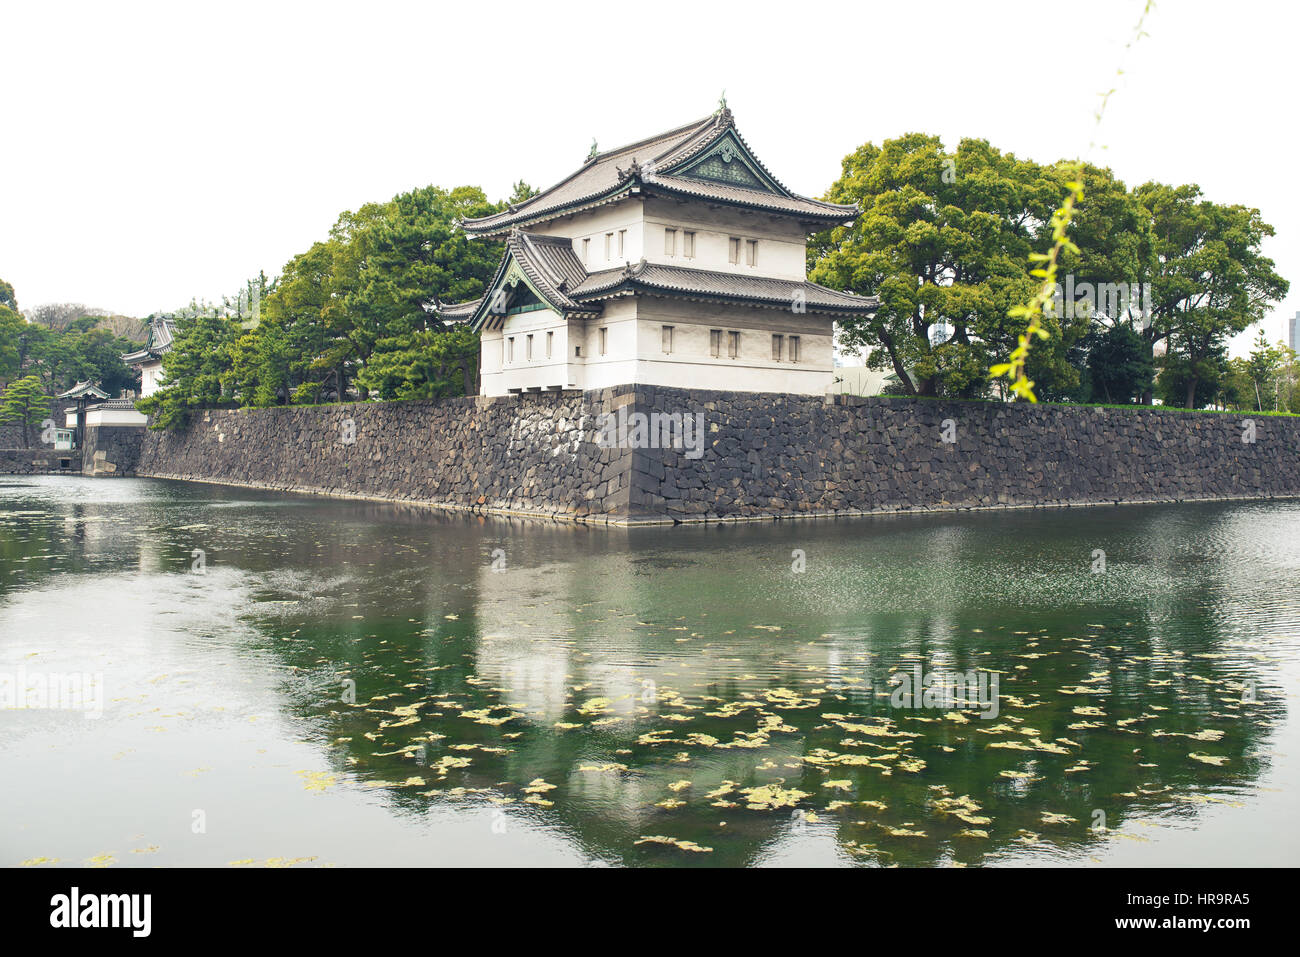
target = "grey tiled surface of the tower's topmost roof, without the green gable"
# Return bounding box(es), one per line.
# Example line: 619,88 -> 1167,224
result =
462,109 -> 858,235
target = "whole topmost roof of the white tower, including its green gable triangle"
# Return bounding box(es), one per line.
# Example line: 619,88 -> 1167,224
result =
462,108 -> 858,237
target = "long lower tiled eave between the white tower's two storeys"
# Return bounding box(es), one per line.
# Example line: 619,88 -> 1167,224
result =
569,260 -> 880,313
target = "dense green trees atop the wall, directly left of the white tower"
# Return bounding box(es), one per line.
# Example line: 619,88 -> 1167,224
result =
140,182 -> 506,428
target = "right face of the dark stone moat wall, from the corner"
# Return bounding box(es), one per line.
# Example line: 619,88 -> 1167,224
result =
632,389 -> 1300,520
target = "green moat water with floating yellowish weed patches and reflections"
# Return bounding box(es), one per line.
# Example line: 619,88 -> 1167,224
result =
0,476 -> 1300,867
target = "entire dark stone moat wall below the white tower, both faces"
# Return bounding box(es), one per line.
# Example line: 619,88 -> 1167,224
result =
126,386 -> 1300,523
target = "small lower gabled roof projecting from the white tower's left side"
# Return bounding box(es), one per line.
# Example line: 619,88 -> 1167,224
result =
434,229 -> 602,332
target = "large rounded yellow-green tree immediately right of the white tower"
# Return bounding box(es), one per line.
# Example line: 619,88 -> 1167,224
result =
809,133 -> 1087,395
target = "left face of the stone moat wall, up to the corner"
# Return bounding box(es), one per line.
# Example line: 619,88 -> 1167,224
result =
138,391 -> 632,520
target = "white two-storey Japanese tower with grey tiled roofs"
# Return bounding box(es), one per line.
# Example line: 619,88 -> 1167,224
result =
437,104 -> 879,395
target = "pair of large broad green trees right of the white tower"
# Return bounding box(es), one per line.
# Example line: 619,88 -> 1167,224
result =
809,133 -> 1287,407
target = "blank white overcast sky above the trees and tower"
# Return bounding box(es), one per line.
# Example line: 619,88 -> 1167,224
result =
0,0 -> 1300,351
